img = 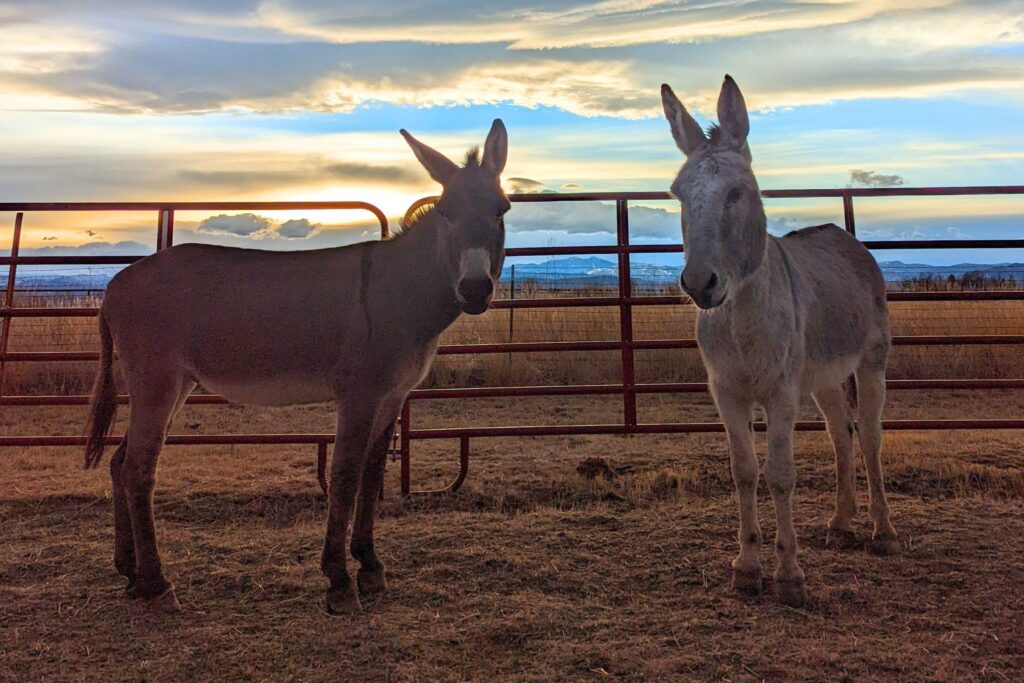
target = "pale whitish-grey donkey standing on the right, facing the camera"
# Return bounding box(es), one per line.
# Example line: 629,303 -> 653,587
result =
662,76 -> 899,606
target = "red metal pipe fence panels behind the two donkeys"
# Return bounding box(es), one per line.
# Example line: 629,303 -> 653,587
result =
0,185 -> 1024,494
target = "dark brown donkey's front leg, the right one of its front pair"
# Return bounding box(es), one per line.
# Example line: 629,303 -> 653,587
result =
351,422 -> 394,595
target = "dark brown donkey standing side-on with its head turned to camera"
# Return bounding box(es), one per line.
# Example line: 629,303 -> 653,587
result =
85,120 -> 510,612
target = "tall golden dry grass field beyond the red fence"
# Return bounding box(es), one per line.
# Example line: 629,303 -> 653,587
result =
4,290 -> 1024,394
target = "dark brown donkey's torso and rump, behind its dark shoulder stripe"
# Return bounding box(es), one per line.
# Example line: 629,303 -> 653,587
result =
102,245 -> 369,404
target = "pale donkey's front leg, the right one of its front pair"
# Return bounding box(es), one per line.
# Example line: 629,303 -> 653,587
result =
765,389 -> 806,607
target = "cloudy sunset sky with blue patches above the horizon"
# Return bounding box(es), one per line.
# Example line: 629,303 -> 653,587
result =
0,0 -> 1024,263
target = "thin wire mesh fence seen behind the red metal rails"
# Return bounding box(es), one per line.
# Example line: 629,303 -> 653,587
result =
4,262 -> 1024,395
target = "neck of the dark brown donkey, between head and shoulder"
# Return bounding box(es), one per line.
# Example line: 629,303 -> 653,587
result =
381,212 -> 462,341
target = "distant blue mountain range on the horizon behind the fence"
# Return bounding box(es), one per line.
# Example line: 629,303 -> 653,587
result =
8,256 -> 1024,291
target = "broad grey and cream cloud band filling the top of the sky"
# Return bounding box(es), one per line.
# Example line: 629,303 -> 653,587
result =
0,0 -> 1024,119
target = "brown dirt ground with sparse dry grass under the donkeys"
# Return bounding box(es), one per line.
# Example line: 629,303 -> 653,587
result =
0,391 -> 1024,681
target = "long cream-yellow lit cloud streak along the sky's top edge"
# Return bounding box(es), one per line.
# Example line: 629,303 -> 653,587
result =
257,0 -> 1013,50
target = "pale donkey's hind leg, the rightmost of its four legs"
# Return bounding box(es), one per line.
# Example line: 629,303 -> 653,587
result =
856,368 -> 900,554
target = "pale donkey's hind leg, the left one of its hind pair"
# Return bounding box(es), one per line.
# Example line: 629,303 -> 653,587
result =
814,385 -> 857,548
